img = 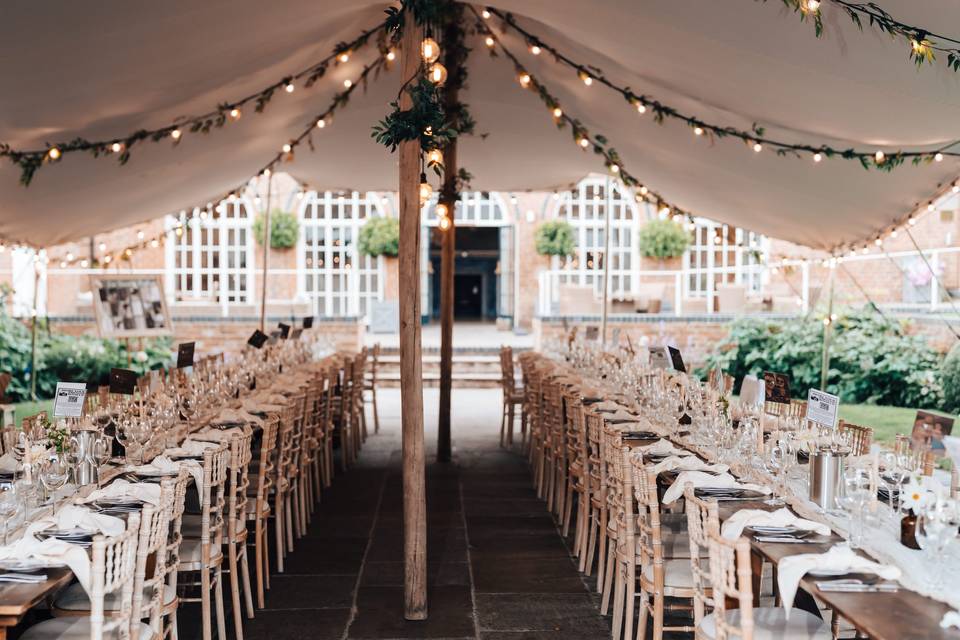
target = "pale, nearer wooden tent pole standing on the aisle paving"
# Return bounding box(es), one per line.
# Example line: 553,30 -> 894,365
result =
399,10 -> 427,620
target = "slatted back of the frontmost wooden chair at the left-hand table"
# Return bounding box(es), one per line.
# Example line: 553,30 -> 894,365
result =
89,513 -> 140,640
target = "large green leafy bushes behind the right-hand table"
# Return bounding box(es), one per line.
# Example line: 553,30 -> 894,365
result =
697,307 -> 944,409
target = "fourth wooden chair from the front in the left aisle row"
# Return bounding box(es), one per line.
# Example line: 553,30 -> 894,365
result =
177,443 -> 230,640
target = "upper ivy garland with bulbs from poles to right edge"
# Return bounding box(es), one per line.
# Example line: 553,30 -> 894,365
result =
486,7 -> 960,171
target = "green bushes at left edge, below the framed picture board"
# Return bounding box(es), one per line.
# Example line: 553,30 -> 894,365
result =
0,315 -> 172,402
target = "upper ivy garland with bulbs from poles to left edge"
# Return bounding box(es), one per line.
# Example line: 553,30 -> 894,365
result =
0,20 -> 389,186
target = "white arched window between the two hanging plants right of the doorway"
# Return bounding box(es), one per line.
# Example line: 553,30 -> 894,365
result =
555,176 -> 642,296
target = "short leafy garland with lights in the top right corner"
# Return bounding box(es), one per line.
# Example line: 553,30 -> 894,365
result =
761,0 -> 960,71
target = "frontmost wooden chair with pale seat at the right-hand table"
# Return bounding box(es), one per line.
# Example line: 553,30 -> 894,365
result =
697,530 -> 831,640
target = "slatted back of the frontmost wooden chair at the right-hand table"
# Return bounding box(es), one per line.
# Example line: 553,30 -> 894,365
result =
707,531 -> 753,640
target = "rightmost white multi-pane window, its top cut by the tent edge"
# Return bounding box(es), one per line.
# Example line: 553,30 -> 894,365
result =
683,218 -> 767,297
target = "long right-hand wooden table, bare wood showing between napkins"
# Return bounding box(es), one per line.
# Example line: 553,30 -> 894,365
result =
624,437 -> 960,640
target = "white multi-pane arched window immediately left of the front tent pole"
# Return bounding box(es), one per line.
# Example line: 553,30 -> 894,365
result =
297,191 -> 384,318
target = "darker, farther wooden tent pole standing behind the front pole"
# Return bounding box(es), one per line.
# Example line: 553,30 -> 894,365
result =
437,5 -> 466,462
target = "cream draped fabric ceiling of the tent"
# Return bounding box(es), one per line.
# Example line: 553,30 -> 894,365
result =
0,0 -> 960,248
